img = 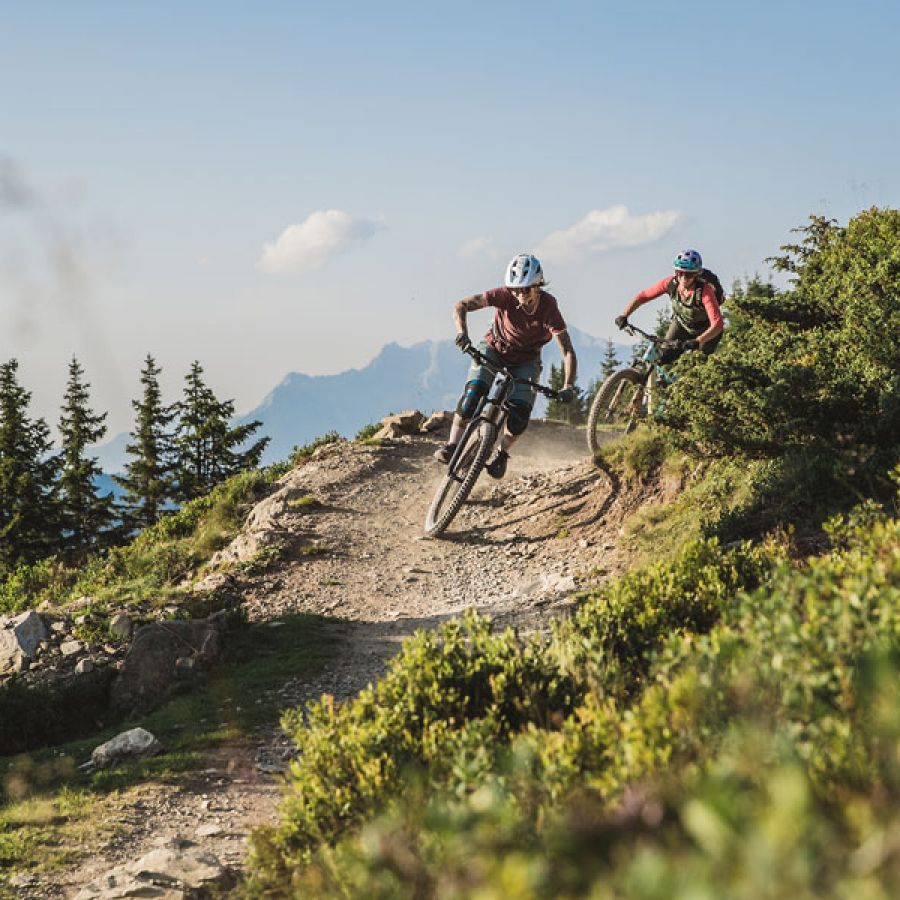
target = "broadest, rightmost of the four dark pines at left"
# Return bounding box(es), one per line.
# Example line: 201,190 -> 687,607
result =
175,361 -> 269,502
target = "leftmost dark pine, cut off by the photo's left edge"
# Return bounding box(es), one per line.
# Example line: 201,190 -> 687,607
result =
0,359 -> 60,568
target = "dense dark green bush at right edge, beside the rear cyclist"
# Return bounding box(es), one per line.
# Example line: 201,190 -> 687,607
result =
666,208 -> 900,506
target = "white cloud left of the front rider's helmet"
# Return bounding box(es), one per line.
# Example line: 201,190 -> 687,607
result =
257,209 -> 381,275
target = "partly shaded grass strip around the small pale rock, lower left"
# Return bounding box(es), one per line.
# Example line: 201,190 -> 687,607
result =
0,616 -> 339,884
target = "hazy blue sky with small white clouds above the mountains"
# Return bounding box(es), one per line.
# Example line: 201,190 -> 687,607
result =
0,0 -> 900,433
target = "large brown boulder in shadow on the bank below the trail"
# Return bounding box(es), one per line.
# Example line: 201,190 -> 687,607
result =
110,617 -> 221,713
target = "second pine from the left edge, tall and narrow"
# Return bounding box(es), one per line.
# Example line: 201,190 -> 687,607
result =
59,357 -> 114,562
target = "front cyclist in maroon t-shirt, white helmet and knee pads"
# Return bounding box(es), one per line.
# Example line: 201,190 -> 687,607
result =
434,253 -> 577,478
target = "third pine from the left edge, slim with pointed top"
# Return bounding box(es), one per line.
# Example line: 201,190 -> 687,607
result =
113,353 -> 174,529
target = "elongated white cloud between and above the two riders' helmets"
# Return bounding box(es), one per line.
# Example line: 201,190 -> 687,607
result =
535,204 -> 681,263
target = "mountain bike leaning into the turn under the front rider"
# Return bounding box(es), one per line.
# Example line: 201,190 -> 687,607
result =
425,346 -> 559,537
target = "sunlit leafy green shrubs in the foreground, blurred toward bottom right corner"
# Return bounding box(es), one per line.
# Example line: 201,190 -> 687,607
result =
249,496 -> 900,898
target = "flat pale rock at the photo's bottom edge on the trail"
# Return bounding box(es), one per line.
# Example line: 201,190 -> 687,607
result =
75,839 -> 234,900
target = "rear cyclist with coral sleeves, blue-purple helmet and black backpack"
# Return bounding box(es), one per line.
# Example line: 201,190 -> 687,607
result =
615,250 -> 725,364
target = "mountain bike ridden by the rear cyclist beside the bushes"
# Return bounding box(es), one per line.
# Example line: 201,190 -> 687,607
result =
587,323 -> 678,454
